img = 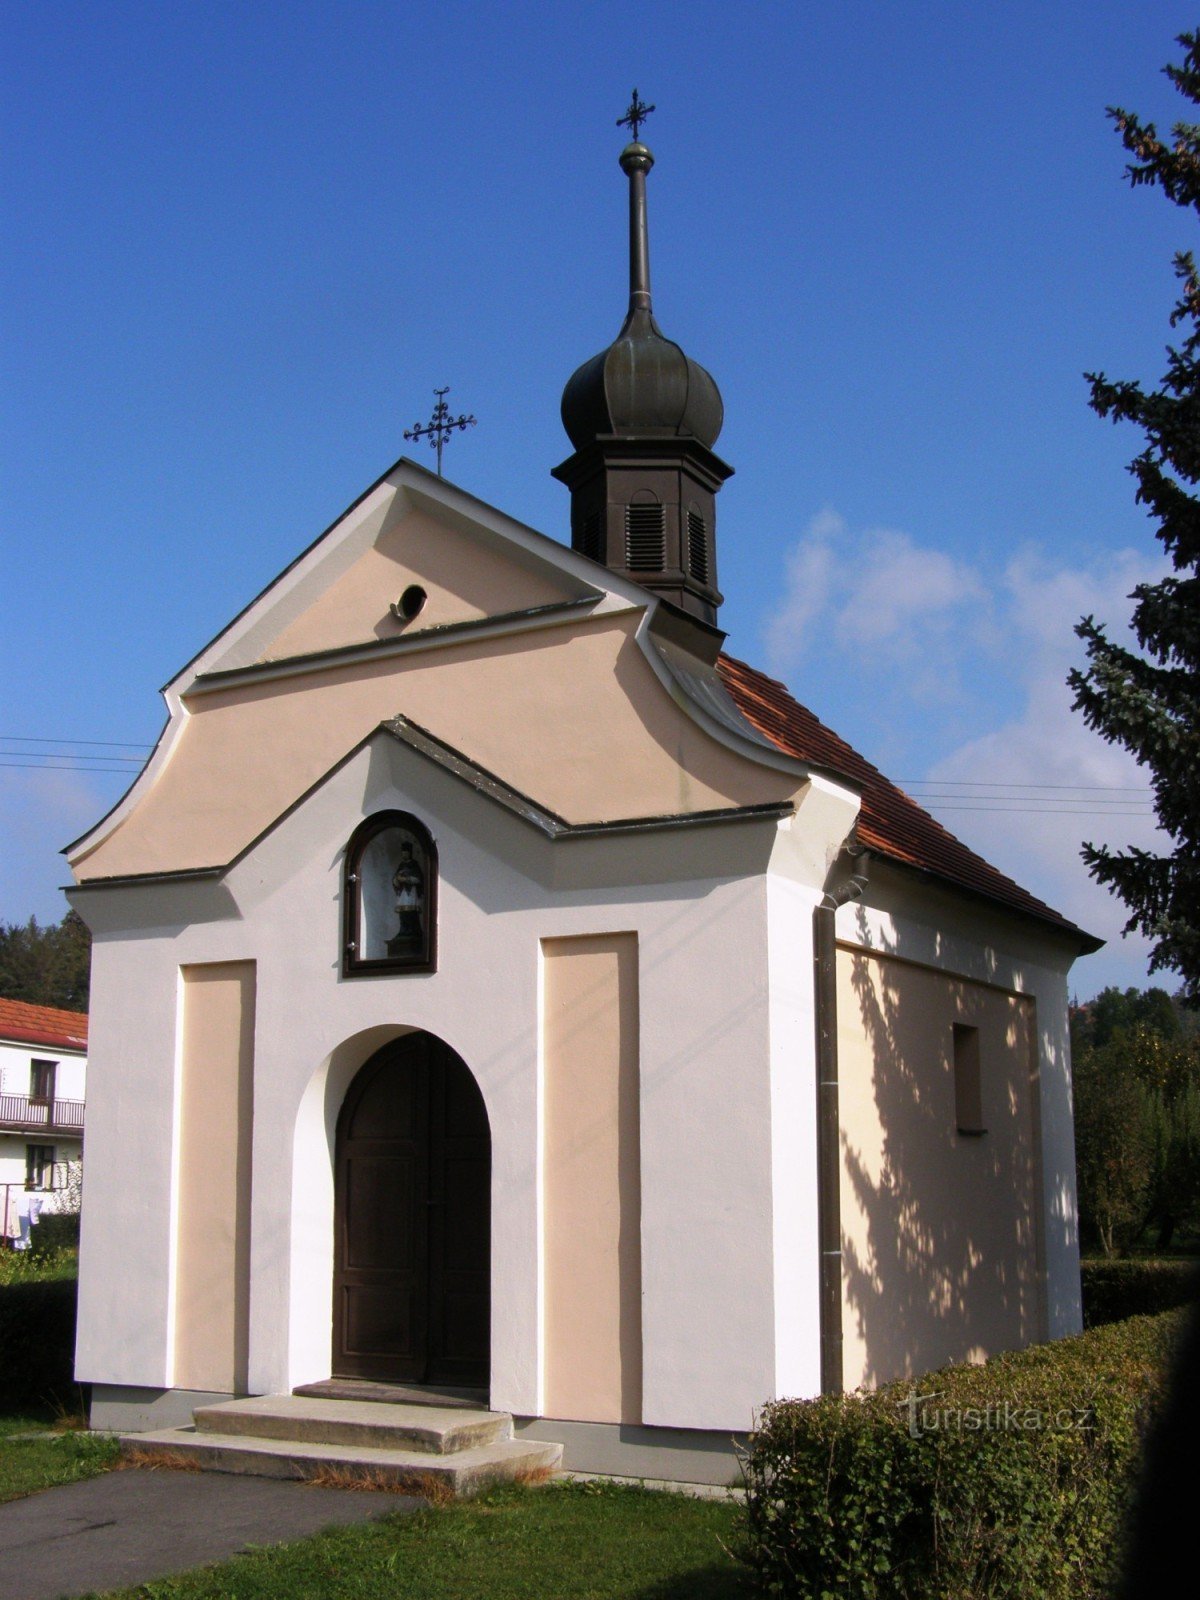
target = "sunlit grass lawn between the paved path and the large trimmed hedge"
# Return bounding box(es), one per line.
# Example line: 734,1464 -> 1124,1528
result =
89,1483 -> 754,1600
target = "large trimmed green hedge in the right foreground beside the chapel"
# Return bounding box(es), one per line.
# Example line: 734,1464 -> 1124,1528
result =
742,1314 -> 1181,1600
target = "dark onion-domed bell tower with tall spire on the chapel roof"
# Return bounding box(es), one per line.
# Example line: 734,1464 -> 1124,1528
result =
554,90 -> 733,626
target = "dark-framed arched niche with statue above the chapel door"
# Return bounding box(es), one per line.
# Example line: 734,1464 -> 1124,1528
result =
342,811 -> 437,978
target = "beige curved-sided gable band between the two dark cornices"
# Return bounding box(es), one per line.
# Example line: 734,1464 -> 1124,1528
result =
80,613 -> 797,882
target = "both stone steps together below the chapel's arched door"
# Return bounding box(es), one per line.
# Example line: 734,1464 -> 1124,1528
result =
120,1395 -> 562,1494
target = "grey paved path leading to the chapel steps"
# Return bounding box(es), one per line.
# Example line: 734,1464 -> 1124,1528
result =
0,1469 -> 421,1600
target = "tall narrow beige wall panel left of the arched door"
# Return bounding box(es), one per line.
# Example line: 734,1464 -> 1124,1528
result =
173,962 -> 254,1394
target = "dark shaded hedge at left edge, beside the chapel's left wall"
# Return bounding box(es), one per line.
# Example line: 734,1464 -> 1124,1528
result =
0,1277 -> 77,1411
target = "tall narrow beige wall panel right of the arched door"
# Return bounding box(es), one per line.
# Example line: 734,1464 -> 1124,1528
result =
542,933 -> 642,1422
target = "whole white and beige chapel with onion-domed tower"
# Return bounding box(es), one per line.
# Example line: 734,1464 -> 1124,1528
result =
69,118 -> 1096,1480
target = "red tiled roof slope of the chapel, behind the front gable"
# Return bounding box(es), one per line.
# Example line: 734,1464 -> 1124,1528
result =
717,656 -> 1099,949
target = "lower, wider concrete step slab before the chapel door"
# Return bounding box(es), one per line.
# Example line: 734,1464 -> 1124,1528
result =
120,1427 -> 562,1494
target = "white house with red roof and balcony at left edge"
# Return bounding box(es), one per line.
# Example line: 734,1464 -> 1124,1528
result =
0,998 -> 88,1238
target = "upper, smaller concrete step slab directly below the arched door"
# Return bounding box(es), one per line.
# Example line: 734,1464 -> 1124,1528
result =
194,1395 -> 512,1456
